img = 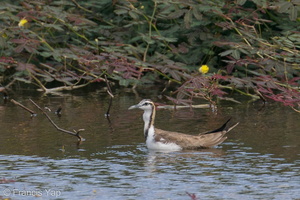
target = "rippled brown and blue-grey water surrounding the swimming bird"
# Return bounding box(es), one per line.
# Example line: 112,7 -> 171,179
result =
0,91 -> 300,200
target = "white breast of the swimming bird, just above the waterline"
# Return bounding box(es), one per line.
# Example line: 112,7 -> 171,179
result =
146,126 -> 182,151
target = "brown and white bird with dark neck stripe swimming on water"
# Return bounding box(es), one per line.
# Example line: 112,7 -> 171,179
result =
128,99 -> 239,150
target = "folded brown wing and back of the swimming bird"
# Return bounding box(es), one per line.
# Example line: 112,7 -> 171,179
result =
155,129 -> 227,149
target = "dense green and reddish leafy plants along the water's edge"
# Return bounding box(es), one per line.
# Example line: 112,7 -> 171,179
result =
0,0 -> 300,109
